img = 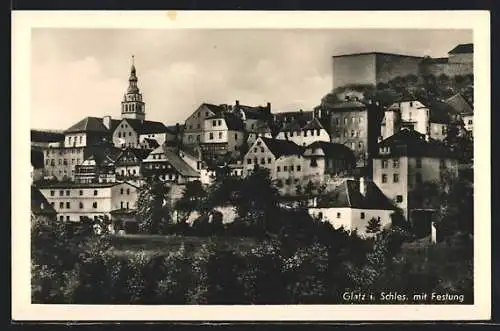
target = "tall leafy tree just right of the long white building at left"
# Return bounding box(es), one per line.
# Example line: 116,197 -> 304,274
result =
136,178 -> 171,234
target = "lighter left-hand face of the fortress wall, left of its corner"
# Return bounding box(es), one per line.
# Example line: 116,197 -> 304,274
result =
333,54 -> 377,89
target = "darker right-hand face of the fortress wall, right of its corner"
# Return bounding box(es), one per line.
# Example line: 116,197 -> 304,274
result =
376,54 -> 422,84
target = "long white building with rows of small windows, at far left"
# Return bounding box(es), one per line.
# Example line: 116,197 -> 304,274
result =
40,182 -> 139,222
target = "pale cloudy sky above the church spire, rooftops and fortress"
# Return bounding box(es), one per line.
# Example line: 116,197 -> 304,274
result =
31,28 -> 472,130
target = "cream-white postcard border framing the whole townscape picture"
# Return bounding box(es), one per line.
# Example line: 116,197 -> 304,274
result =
12,11 -> 491,321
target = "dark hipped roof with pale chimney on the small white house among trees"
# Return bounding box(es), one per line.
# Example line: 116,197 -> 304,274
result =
318,179 -> 395,210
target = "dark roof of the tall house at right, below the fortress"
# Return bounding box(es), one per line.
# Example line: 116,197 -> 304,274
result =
376,128 -> 454,158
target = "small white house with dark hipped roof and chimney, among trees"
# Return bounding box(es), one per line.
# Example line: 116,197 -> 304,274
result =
309,178 -> 395,237
